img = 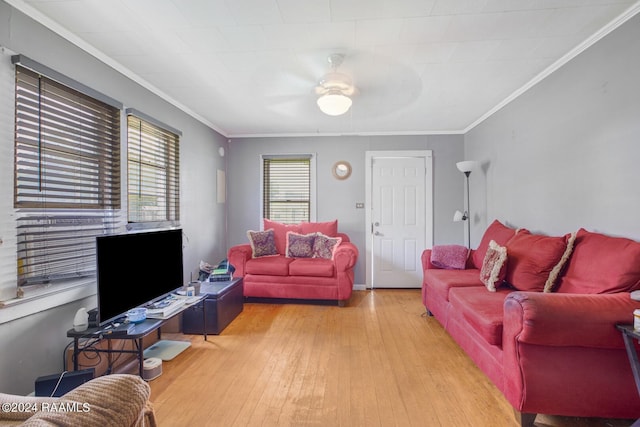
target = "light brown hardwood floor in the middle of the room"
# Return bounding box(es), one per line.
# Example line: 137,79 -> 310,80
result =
150,290 -> 632,427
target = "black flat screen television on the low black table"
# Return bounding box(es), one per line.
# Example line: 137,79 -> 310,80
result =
96,229 -> 183,326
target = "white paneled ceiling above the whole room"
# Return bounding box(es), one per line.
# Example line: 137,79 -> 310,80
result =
7,0 -> 640,138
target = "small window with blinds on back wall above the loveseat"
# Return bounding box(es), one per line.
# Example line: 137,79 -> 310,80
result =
262,155 -> 312,223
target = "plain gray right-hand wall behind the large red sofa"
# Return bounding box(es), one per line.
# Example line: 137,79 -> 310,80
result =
465,16 -> 640,243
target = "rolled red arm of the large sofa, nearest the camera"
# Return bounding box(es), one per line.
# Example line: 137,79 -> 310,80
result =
504,292 -> 640,349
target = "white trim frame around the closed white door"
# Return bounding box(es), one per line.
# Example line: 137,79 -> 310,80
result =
364,150 -> 433,289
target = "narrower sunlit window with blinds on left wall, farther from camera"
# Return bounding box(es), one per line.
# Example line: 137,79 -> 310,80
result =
127,109 -> 180,227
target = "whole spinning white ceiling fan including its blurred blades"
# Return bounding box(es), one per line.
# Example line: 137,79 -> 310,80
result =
254,50 -> 422,122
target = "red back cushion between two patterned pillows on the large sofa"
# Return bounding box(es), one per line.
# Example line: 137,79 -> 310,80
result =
505,231 -> 569,292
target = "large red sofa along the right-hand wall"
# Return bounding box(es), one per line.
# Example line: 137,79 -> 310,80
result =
422,221 -> 640,425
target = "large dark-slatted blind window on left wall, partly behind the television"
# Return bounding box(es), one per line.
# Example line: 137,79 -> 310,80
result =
14,65 -> 120,286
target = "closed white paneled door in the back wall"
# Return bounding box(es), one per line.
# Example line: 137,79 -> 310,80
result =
367,152 -> 433,288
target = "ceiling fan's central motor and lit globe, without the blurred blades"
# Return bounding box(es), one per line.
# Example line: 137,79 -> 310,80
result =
315,53 -> 356,116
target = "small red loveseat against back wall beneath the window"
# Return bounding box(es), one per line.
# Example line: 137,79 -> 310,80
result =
228,219 -> 358,305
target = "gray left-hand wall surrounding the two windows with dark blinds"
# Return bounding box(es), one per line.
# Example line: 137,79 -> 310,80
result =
0,2 -> 227,393
